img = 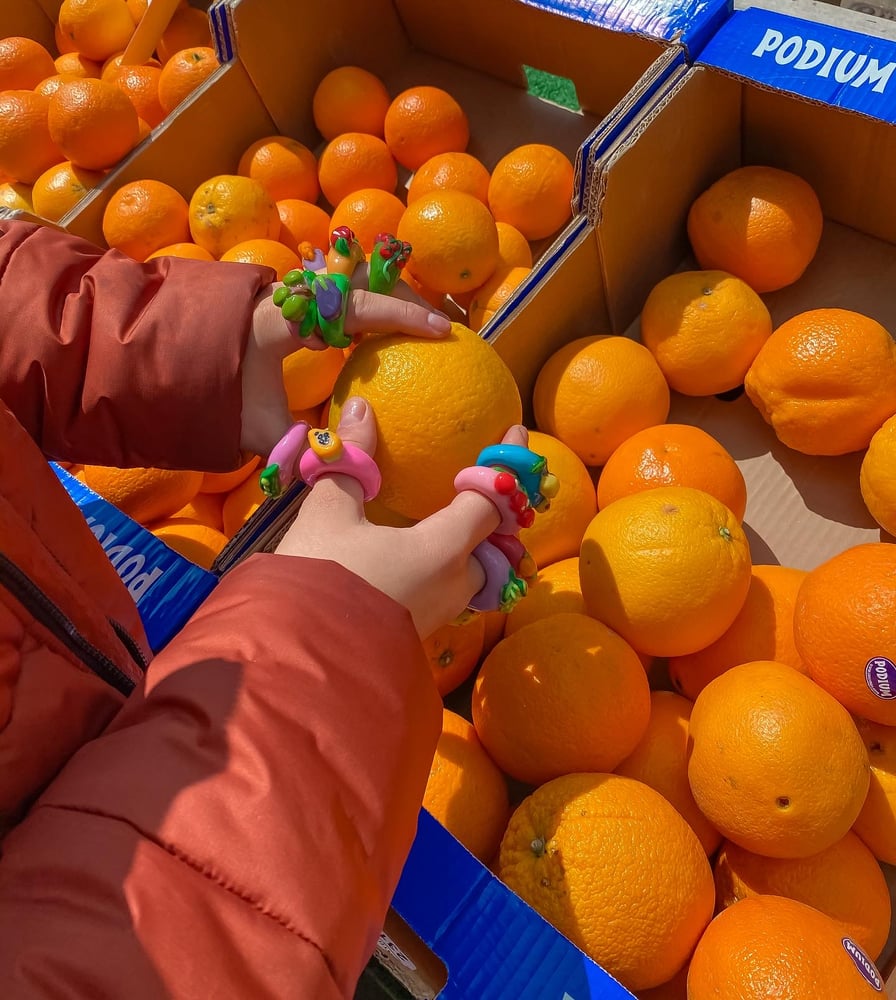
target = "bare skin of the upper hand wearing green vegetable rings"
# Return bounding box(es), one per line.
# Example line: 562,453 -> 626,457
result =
240,278 -> 451,458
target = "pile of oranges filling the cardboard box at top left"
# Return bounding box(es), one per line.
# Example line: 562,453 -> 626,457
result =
0,0 -> 218,222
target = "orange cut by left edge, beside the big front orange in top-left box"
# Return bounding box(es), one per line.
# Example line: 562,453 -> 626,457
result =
0,90 -> 65,184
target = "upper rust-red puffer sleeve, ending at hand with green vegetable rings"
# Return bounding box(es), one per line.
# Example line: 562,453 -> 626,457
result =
0,220 -> 274,470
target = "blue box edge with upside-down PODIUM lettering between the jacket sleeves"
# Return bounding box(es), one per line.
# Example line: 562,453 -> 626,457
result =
50,462 -> 218,652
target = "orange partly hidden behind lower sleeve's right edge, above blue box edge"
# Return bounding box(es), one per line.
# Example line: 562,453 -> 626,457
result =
423,708 -> 510,863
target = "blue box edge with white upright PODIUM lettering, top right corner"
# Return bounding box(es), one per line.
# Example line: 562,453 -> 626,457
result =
699,7 -> 896,124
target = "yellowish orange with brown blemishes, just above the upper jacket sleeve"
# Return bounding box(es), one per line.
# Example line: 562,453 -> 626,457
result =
189,174 -> 280,257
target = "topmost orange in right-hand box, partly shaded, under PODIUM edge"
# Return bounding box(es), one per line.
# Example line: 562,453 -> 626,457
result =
688,166 -> 824,292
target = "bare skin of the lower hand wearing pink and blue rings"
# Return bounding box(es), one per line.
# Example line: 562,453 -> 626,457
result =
277,397 -> 528,638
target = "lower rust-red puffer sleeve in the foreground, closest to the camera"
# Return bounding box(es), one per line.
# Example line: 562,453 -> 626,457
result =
0,555 -> 441,1000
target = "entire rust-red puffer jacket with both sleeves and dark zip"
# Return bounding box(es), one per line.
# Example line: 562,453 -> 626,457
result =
0,221 -> 440,1000
